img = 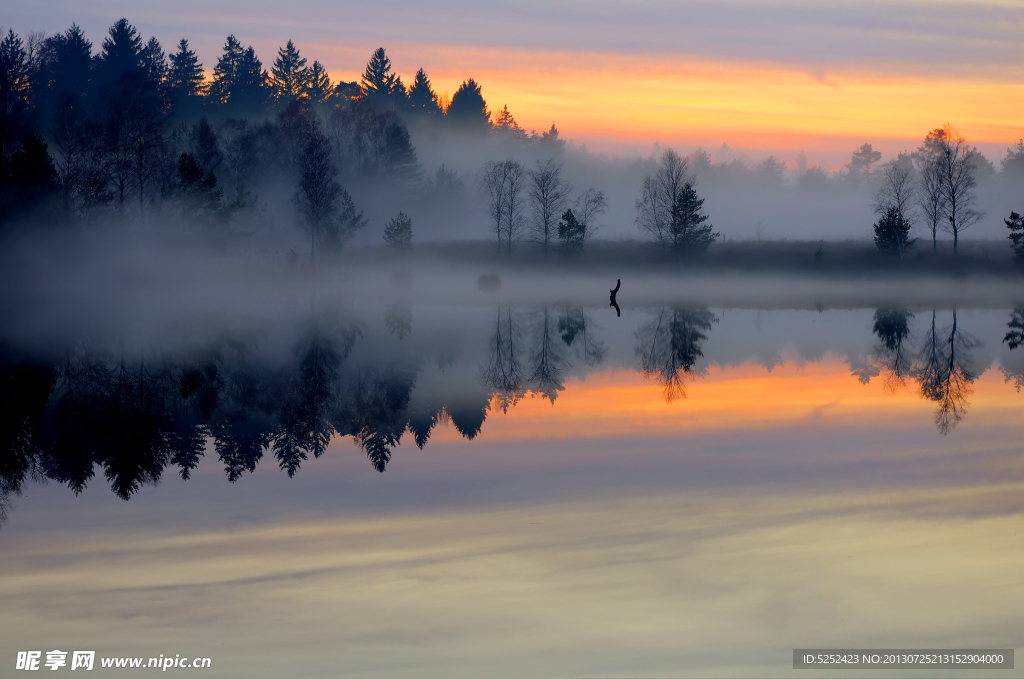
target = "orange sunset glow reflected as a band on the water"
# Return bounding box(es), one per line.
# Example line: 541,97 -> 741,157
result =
435,359 -> 1024,442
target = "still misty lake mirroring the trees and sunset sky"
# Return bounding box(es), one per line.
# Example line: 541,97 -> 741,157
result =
0,270 -> 1024,678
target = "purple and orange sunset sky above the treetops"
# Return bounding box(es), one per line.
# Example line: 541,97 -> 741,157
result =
3,0 -> 1024,163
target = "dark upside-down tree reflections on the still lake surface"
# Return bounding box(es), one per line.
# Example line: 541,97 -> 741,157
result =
0,305 -> 1024,507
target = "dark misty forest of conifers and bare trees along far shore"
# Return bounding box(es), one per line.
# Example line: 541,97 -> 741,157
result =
0,18 -> 1024,260
